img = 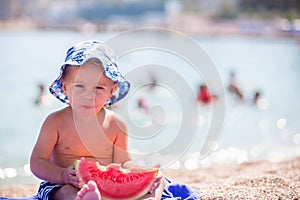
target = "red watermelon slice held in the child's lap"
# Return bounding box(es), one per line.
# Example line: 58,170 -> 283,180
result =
74,159 -> 158,200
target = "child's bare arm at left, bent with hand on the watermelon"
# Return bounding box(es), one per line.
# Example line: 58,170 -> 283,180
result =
30,113 -> 78,185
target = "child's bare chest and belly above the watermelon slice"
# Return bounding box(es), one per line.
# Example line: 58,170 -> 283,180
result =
53,119 -> 116,162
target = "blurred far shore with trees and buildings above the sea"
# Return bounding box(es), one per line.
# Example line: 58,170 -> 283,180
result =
0,0 -> 300,36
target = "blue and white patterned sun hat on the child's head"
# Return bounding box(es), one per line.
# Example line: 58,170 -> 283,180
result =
49,41 -> 130,106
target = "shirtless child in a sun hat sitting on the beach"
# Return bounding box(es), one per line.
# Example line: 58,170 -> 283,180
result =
30,41 -> 163,200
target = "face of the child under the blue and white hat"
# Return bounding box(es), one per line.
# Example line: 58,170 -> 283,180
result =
63,61 -> 116,113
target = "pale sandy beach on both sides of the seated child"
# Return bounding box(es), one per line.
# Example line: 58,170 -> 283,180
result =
0,157 -> 300,200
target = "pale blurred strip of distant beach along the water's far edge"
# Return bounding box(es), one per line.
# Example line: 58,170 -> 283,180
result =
0,15 -> 300,44
